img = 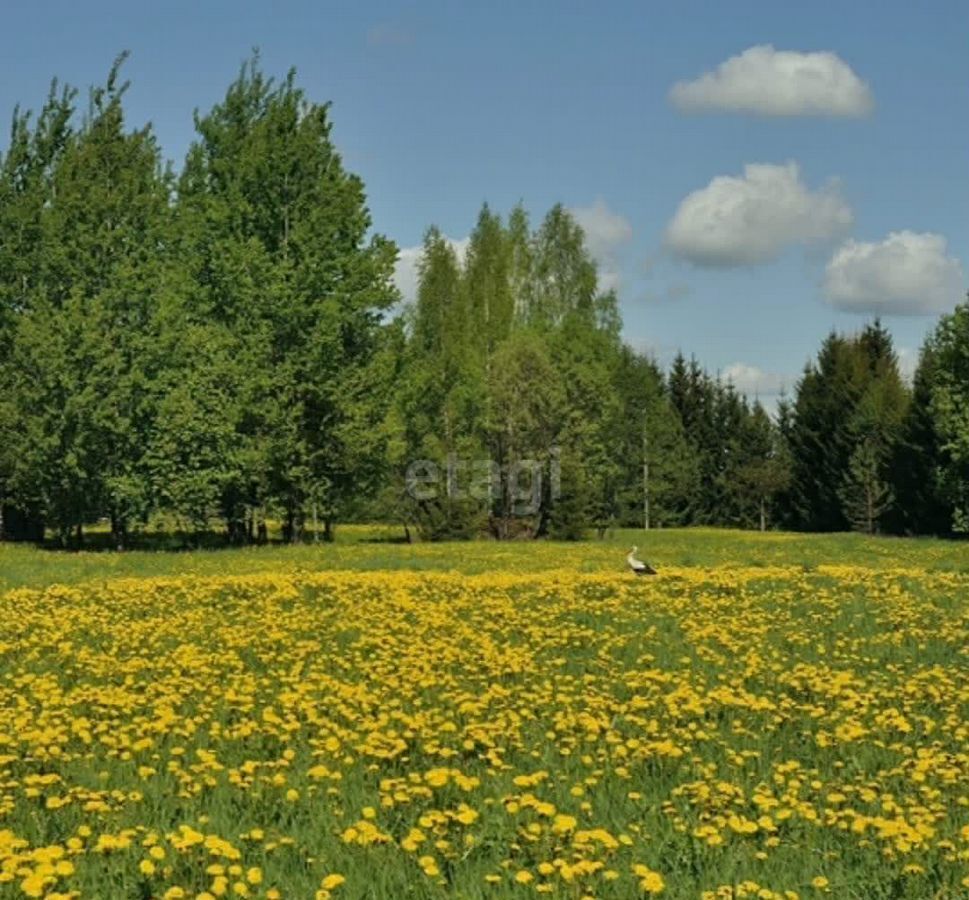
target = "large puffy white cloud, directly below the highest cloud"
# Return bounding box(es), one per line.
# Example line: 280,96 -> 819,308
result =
666,162 -> 853,266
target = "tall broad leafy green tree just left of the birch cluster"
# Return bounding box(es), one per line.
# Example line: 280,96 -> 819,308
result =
179,59 -> 396,539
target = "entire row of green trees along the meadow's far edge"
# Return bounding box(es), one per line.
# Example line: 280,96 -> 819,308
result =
0,59 -> 969,547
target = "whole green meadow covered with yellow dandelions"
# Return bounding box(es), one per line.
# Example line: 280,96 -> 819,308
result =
0,529 -> 969,900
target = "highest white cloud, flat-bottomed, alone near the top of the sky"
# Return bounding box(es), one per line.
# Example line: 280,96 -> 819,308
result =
670,44 -> 874,117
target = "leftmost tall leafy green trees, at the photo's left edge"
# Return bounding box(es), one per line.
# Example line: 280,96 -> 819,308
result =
2,57 -> 169,544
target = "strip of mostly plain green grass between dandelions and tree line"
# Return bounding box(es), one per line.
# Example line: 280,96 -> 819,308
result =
0,526 -> 969,591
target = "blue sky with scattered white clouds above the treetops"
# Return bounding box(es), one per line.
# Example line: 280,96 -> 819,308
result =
0,0 -> 969,400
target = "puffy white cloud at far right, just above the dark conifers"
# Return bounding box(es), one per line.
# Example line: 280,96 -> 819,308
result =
824,231 -> 965,315
